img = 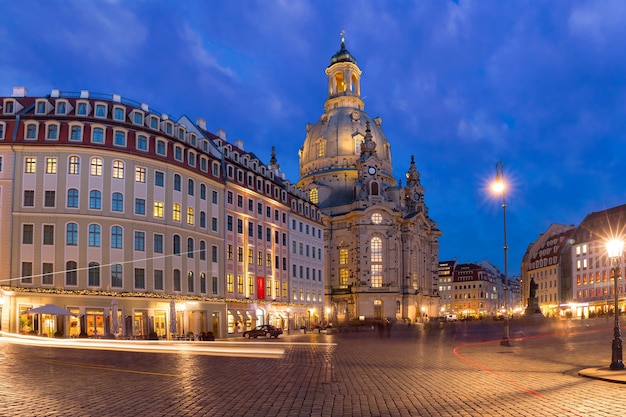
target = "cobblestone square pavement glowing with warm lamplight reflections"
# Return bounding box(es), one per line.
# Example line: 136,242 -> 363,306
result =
0,319 -> 626,417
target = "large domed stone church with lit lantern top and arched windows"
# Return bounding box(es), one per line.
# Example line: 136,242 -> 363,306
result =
297,32 -> 441,324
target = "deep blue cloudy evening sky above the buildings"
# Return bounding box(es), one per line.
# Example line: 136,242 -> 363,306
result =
0,0 -> 626,275
